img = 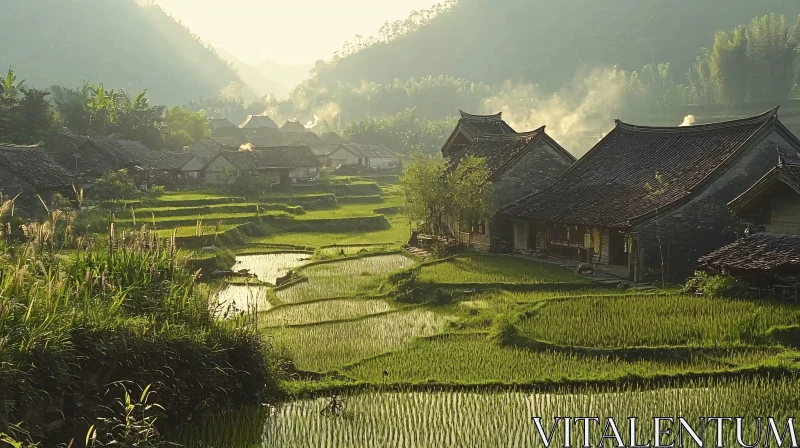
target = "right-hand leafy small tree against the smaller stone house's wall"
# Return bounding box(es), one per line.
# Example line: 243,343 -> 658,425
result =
448,156 -> 494,238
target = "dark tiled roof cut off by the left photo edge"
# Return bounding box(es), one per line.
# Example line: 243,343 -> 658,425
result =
0,144 -> 72,189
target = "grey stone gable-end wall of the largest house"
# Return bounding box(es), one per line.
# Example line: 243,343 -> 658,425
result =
633,132 -> 792,280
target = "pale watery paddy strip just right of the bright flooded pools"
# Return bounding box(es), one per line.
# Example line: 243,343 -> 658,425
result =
276,254 -> 414,303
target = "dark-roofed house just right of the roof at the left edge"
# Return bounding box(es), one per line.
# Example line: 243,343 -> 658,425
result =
42,133 -> 155,184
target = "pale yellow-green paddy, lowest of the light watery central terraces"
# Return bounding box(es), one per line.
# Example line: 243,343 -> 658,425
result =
265,308 -> 448,372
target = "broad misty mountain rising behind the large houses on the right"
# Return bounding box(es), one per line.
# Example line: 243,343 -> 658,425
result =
316,0 -> 800,90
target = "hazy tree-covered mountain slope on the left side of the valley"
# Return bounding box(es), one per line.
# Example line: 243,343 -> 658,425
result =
0,0 -> 239,104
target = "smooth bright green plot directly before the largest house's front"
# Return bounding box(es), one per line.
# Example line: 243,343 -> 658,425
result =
420,255 -> 591,284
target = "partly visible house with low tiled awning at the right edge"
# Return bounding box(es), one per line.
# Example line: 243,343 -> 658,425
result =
698,154 -> 800,300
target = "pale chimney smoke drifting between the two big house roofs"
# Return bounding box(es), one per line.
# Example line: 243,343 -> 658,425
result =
483,68 -> 627,156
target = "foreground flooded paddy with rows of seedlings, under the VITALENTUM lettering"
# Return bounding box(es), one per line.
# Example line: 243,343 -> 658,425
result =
253,379 -> 800,448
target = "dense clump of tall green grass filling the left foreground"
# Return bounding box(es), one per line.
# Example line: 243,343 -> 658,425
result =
0,231 -> 280,442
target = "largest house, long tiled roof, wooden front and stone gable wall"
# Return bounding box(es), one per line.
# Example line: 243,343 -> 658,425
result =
501,109 -> 800,281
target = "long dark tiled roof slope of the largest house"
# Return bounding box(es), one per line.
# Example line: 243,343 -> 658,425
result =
502,109 -> 777,228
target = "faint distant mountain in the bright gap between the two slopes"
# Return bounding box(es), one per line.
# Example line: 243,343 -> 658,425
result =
217,48 -> 314,98
